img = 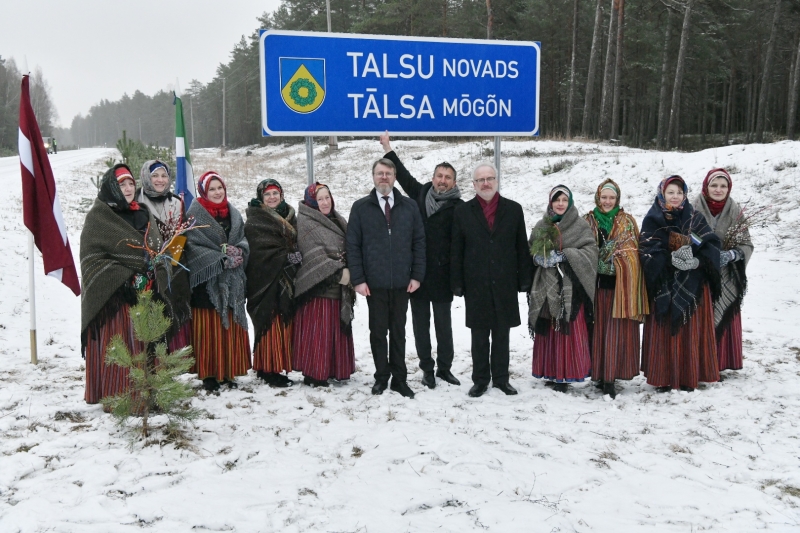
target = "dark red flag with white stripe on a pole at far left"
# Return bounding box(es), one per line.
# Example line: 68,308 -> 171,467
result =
19,75 -> 81,296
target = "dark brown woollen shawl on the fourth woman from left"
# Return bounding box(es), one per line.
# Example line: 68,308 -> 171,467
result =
244,205 -> 297,347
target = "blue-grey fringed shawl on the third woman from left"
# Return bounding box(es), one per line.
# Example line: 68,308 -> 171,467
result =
185,198 -> 250,329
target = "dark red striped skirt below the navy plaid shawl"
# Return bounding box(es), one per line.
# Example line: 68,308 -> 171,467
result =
642,285 -> 719,389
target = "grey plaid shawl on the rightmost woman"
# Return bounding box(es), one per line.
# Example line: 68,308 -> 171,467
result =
694,194 -> 753,335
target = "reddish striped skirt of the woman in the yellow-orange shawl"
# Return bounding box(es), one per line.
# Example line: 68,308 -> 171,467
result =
592,288 -> 641,382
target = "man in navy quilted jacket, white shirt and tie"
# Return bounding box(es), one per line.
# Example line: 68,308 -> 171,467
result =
347,159 -> 425,398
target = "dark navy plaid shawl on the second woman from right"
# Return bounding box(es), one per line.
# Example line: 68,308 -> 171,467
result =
639,198 -> 720,335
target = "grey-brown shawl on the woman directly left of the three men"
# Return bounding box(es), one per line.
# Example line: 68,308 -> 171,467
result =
294,202 -> 355,329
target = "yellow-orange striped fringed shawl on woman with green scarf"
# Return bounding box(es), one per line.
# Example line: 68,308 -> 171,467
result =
584,208 -> 650,322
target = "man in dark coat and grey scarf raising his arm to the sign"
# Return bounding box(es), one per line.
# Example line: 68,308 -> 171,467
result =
381,131 -> 464,389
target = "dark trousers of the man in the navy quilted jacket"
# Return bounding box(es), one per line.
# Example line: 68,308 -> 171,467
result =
367,287 -> 409,383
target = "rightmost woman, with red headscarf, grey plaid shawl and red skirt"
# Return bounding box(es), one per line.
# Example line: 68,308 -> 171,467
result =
694,168 -> 753,371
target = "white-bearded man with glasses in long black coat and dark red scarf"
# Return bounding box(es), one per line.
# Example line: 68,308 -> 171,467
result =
451,163 -> 533,397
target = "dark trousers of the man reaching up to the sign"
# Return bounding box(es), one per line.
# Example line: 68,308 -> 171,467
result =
411,296 -> 453,372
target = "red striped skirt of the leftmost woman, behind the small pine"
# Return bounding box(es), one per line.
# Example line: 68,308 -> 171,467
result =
84,305 -> 145,403
